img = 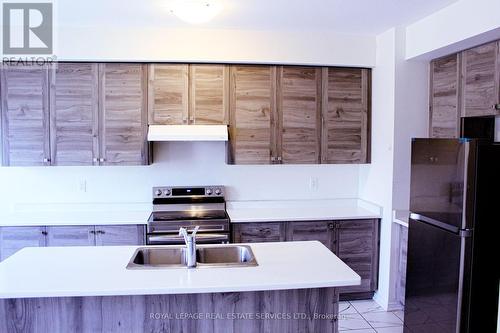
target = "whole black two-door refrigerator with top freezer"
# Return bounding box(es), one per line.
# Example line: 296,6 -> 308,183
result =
404,139 -> 500,333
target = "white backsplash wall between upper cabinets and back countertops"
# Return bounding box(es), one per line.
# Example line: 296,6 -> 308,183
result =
0,142 -> 359,212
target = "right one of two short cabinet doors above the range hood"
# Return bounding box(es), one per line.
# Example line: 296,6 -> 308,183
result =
189,65 -> 229,125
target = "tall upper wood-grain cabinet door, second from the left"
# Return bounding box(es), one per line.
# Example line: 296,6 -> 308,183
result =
50,63 -> 99,165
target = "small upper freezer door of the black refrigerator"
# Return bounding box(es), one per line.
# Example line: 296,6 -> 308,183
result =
410,139 -> 477,229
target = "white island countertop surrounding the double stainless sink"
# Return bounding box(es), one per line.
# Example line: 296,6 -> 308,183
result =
0,241 -> 361,298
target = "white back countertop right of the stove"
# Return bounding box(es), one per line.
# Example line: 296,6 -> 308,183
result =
227,199 -> 382,223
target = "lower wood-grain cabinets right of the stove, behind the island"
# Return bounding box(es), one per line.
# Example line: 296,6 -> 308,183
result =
232,219 -> 379,300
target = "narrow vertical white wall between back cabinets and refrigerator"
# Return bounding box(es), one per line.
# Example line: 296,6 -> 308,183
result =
359,29 -> 396,308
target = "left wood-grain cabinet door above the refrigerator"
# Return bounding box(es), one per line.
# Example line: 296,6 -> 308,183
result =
429,54 -> 460,138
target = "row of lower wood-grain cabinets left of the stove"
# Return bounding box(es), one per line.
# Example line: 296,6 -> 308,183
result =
0,225 -> 145,261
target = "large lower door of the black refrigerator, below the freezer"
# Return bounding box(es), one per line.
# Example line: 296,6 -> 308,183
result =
404,219 -> 470,333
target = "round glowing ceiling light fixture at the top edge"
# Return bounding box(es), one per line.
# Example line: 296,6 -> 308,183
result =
170,0 -> 222,24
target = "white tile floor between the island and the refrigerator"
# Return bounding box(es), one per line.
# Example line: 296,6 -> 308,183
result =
339,300 -> 403,333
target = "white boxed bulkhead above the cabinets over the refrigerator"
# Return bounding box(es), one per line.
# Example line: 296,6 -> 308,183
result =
406,0 -> 500,60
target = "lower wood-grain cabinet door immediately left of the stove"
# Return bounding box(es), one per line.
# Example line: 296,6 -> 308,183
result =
95,225 -> 145,246
